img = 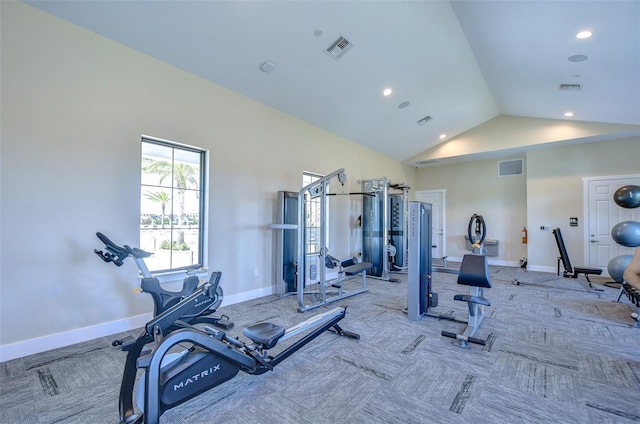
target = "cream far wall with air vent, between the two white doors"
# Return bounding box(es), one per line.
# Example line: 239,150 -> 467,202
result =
415,137 -> 640,271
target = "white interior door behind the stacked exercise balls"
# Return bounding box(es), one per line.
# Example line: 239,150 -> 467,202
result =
584,175 -> 640,275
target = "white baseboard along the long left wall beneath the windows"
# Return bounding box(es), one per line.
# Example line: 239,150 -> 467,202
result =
0,286 -> 274,362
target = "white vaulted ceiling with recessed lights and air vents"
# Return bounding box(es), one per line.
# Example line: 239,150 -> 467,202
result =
26,0 -> 640,160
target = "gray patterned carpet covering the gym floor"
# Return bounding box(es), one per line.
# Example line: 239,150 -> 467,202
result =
0,264 -> 640,424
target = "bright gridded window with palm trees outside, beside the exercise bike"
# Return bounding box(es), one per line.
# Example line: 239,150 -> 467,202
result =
140,138 -> 206,272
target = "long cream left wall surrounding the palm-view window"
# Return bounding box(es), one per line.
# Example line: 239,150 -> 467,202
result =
0,2 -> 414,359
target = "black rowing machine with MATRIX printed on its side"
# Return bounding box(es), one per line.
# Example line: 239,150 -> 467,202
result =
115,272 -> 360,424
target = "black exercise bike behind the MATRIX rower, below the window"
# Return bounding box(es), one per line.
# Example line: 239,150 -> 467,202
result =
94,233 -> 233,329
